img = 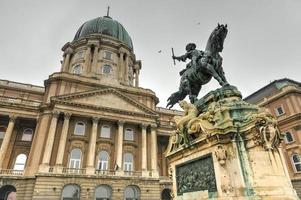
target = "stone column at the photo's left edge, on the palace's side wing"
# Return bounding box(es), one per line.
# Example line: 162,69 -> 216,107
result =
0,115 -> 16,169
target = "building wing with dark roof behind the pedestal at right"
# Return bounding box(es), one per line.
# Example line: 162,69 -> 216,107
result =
245,78 -> 301,197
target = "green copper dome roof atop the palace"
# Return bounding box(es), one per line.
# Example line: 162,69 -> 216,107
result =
74,16 -> 133,49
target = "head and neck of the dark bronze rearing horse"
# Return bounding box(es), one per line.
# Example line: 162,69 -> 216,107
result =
206,24 -> 228,53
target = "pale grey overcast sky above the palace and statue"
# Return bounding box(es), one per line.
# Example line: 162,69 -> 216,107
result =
0,0 -> 301,106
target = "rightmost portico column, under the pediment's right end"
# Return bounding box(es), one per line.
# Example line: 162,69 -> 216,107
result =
151,124 -> 159,177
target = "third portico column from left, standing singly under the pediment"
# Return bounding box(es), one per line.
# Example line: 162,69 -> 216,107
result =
86,117 -> 99,174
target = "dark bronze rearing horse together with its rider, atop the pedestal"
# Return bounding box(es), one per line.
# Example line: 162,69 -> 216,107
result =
166,24 -> 229,109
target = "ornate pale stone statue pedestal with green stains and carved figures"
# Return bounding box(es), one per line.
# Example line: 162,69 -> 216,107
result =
166,86 -> 298,200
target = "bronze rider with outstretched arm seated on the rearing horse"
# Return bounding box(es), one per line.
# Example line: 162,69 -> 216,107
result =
172,43 -> 204,76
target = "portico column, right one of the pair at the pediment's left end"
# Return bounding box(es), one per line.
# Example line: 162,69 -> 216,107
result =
56,113 -> 71,173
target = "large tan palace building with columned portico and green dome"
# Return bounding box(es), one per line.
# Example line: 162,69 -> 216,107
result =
0,16 -> 181,200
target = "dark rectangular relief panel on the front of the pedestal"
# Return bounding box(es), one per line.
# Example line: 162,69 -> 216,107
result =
176,155 -> 217,195
